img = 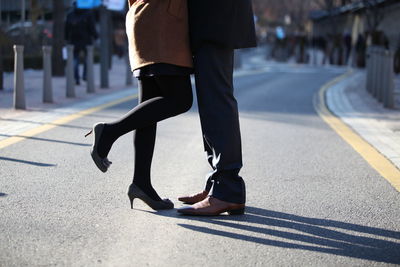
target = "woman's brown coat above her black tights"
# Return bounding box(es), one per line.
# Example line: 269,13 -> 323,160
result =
126,0 -> 193,71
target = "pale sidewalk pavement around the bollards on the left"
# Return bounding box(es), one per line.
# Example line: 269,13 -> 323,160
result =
0,57 -> 137,141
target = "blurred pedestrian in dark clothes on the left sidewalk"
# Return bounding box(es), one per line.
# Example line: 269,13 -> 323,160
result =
65,2 -> 98,85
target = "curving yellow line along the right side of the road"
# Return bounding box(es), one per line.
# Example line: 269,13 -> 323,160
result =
314,71 -> 400,192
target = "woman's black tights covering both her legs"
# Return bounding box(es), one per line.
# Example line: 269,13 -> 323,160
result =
99,75 -> 193,200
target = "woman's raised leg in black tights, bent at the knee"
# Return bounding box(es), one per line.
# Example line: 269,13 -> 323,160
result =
98,76 -> 193,158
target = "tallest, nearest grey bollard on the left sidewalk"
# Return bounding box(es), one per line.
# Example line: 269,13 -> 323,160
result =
14,45 -> 26,109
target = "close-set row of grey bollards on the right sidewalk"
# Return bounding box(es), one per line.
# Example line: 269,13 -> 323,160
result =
367,46 -> 395,108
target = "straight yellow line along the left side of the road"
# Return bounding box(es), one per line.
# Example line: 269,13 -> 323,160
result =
0,94 -> 137,149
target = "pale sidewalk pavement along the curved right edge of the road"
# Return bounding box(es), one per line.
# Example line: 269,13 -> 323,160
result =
326,70 -> 400,169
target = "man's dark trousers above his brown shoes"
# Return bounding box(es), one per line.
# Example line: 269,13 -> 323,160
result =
194,44 -> 246,203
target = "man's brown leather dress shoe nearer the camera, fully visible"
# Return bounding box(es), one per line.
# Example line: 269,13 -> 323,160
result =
178,196 -> 245,216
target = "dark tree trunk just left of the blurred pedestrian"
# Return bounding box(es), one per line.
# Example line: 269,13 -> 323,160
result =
52,0 -> 65,76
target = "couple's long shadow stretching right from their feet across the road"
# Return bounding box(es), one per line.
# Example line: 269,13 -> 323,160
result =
151,207 -> 400,264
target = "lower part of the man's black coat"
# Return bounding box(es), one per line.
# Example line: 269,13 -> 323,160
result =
188,0 -> 257,51
